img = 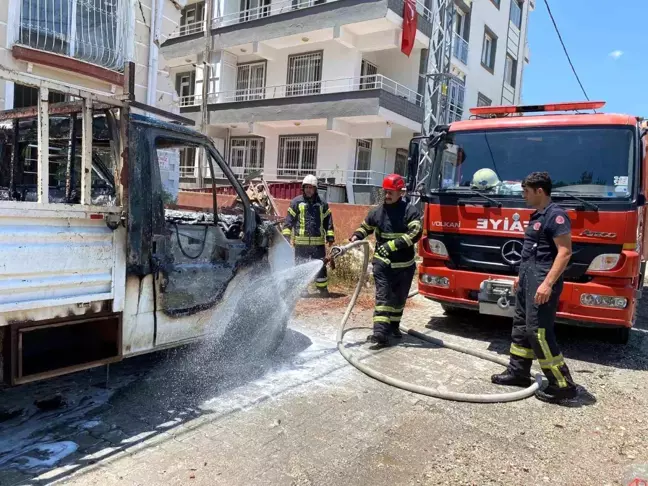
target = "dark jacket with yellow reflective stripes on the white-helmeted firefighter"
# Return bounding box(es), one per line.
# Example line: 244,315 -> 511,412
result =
282,194 -> 335,246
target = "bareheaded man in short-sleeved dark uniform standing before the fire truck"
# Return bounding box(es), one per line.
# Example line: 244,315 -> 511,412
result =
492,172 -> 595,406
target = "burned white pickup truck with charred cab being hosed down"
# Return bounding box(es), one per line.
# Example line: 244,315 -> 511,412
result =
0,68 -> 296,385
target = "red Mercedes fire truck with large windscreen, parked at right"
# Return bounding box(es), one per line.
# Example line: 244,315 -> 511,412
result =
410,102 -> 648,343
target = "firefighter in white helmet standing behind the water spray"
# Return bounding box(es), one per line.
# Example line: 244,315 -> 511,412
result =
282,175 -> 335,297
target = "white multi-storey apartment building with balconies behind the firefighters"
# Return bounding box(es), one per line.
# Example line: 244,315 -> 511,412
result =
162,0 -> 532,202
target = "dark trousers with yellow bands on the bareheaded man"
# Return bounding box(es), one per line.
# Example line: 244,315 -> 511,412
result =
509,259 -> 576,391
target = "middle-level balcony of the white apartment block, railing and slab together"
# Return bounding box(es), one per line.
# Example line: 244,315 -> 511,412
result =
180,74 -> 423,126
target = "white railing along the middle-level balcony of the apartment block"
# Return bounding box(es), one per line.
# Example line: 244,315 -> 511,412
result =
180,74 -> 423,107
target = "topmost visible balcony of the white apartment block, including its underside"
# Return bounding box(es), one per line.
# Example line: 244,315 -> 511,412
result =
162,0 -> 432,59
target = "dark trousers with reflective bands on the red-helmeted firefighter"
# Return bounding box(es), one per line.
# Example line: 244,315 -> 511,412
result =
373,259 -> 416,339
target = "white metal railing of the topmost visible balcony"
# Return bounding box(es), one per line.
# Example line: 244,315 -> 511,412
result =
169,0 -> 432,38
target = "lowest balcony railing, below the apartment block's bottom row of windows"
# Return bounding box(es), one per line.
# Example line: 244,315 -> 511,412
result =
180,167 -> 386,187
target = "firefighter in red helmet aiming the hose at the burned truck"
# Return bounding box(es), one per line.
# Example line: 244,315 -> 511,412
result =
351,174 -> 423,349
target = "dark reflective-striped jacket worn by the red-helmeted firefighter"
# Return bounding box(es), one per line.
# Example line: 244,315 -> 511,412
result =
353,199 -> 423,268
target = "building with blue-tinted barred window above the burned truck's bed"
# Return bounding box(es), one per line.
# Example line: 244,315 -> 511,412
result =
0,0 -> 185,118
